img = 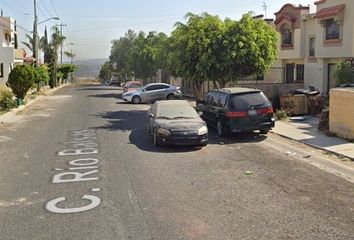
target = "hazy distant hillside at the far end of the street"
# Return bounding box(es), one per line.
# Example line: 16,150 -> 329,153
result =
74,58 -> 107,78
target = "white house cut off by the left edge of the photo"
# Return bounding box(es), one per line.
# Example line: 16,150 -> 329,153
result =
0,16 -> 17,84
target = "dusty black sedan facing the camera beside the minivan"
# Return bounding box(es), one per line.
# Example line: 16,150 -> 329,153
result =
146,100 -> 208,147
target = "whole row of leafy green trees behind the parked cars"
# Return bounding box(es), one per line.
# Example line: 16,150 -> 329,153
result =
102,13 -> 278,98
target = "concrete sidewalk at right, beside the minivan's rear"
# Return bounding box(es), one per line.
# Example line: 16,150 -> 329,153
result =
271,117 -> 354,160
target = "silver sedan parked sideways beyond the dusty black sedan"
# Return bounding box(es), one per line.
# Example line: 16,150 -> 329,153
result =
122,83 -> 182,104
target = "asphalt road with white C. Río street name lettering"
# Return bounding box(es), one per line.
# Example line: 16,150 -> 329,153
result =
0,85 -> 354,240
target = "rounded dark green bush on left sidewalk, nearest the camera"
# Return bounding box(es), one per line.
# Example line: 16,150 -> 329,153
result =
8,65 -> 35,99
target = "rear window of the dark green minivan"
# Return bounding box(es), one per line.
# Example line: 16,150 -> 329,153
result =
229,92 -> 271,110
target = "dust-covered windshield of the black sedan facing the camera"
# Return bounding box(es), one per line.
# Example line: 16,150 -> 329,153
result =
156,104 -> 198,119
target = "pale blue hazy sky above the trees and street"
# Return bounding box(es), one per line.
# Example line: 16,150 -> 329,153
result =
0,0 -> 315,61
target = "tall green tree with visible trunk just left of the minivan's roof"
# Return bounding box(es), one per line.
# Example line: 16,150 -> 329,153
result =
169,13 -> 222,99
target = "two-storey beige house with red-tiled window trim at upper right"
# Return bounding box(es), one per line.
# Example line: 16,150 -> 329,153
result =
274,0 -> 354,93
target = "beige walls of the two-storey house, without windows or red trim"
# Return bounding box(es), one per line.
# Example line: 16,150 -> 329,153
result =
278,0 -> 354,93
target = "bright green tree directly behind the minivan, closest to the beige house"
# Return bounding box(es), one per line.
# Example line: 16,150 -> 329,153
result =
215,14 -> 278,87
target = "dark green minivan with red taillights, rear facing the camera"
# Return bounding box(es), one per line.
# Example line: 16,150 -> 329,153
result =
197,88 -> 274,136
